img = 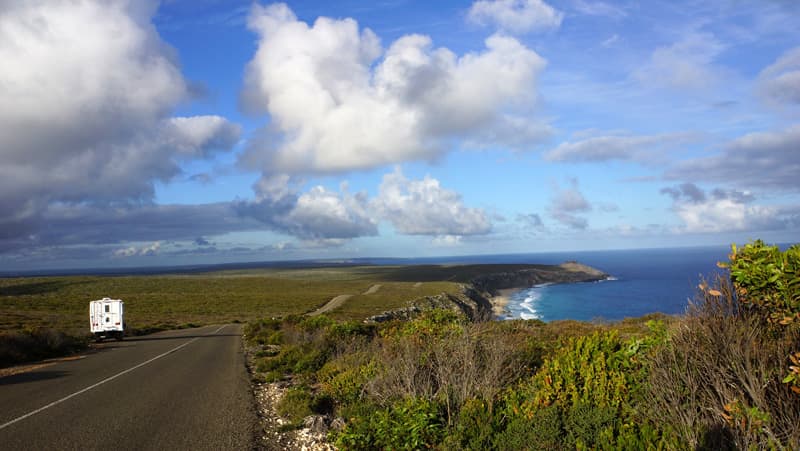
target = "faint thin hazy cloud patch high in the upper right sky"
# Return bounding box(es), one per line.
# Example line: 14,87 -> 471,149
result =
633,32 -> 725,90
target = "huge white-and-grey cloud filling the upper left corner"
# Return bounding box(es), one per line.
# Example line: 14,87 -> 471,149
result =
0,0 -> 240,244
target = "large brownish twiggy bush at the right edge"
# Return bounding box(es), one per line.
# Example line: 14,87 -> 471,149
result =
648,275 -> 800,449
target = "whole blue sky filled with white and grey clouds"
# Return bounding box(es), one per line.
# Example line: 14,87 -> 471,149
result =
0,0 -> 800,271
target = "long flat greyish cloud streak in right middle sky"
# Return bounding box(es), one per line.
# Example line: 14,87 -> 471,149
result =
544,134 -> 688,162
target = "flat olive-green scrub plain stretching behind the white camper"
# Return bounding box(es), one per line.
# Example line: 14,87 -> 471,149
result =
0,266 -> 473,335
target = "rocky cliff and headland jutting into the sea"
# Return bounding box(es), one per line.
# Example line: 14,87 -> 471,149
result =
367,262 -> 608,322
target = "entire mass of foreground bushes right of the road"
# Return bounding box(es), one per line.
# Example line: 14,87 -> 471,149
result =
247,242 -> 800,450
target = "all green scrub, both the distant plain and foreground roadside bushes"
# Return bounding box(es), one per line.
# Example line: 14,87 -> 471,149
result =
6,241 -> 800,450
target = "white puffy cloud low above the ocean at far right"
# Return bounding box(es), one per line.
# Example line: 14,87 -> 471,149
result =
661,183 -> 796,233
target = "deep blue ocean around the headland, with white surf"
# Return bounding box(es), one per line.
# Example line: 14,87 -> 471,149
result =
494,246 -> 730,321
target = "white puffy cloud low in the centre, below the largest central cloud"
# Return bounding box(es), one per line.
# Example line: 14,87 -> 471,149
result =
373,169 -> 492,236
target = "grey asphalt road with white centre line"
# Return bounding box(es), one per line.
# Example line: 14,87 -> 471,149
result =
0,325 -> 257,450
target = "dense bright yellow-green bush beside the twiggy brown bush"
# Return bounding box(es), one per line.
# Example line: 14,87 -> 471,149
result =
504,322 -> 666,449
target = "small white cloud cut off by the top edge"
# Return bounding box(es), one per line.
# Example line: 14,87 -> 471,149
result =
467,0 -> 564,34
